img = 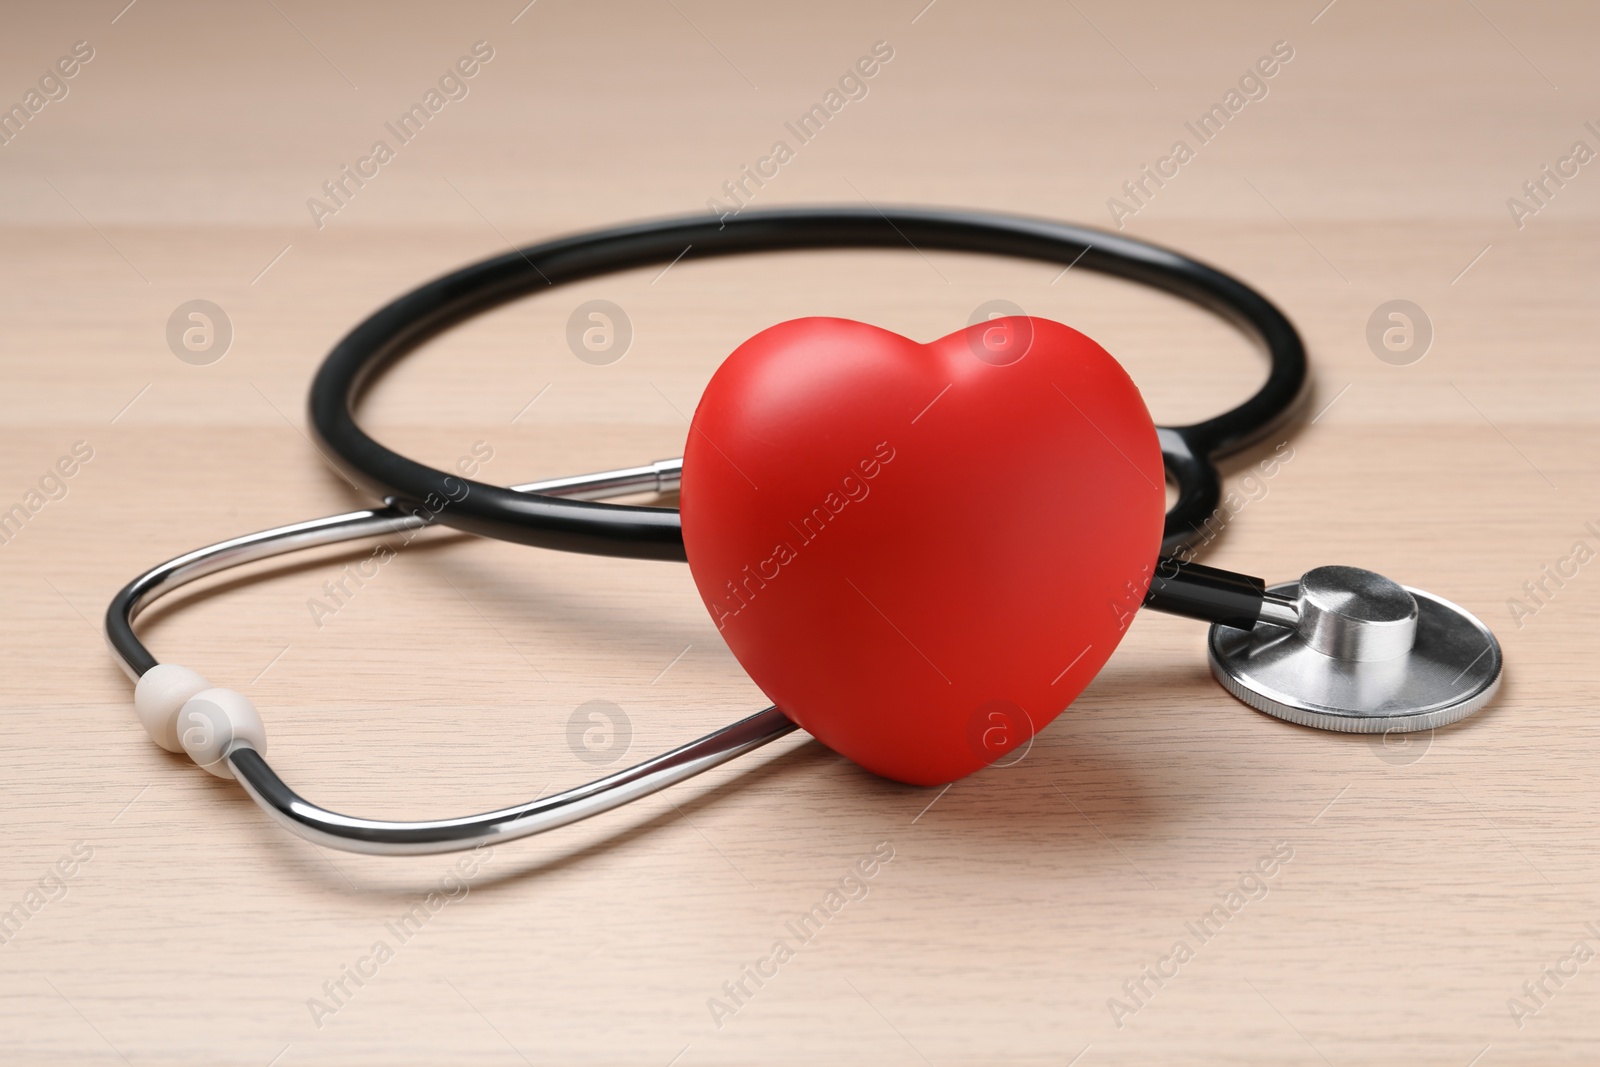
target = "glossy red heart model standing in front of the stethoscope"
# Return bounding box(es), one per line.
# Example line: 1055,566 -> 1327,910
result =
682,317 -> 1165,785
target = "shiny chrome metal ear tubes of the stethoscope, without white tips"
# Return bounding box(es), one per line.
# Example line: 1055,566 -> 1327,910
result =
106,459 -> 797,856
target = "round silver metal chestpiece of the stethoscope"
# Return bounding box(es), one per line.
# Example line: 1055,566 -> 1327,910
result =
1206,566 -> 1502,734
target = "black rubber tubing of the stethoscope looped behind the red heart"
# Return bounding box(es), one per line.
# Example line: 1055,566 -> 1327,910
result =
310,206 -> 1307,560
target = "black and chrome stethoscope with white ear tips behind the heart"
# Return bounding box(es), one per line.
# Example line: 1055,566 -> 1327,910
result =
106,208 -> 1502,854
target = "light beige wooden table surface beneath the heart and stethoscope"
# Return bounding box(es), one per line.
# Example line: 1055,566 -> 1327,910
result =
0,0 -> 1600,1067
